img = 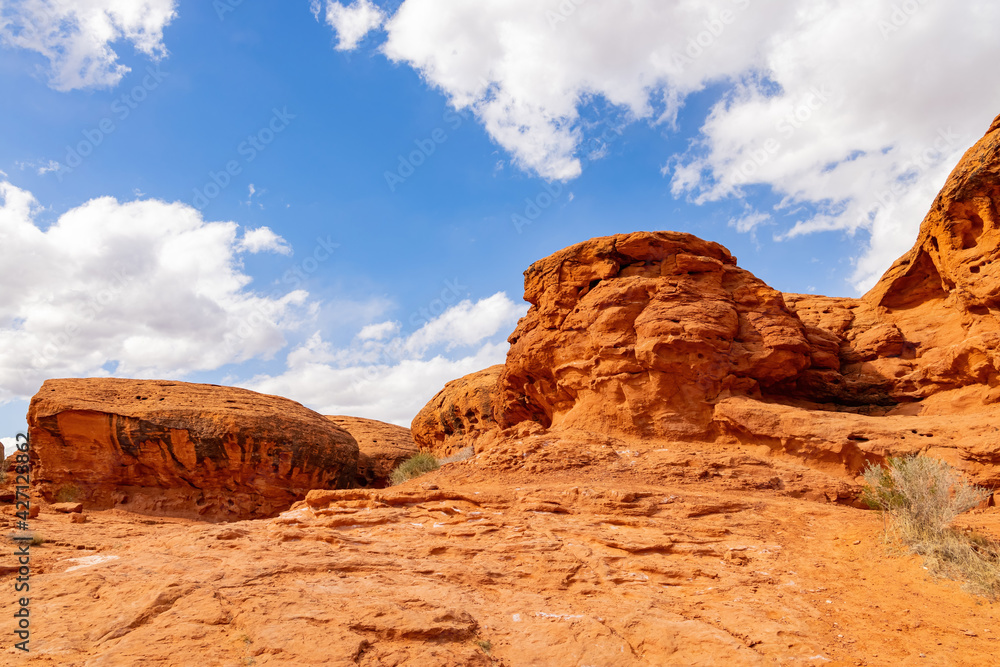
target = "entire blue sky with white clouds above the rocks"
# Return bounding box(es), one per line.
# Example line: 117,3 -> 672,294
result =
0,0 -> 1000,454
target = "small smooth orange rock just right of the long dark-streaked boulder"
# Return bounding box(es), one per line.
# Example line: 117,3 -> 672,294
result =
327,415 -> 420,488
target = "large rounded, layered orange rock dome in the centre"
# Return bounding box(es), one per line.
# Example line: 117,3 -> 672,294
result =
495,232 -> 811,436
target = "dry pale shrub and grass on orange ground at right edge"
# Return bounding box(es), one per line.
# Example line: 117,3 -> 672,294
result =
861,455 -> 1000,599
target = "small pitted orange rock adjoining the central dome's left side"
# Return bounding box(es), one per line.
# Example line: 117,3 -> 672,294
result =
410,365 -> 503,457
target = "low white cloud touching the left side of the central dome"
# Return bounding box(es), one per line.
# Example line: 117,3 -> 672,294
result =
244,292 -> 527,426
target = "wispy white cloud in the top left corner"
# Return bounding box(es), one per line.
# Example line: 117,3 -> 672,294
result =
0,0 -> 177,91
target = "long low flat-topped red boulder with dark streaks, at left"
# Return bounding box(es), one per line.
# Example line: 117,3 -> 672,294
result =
28,378 -> 358,520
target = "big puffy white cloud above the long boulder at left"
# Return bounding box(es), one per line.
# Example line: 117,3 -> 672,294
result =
0,181 -> 313,401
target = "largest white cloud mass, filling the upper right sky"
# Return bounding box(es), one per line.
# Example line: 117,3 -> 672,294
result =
332,0 -> 1000,290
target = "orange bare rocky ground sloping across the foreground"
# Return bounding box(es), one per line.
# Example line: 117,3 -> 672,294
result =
0,434 -> 1000,667
